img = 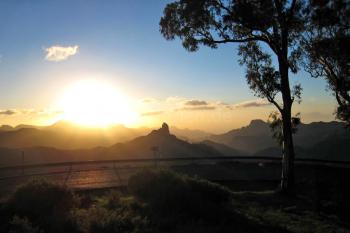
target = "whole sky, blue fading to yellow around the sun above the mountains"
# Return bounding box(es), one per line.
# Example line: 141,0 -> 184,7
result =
0,0 -> 335,133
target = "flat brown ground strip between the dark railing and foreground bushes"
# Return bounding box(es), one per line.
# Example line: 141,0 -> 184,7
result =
0,156 -> 350,190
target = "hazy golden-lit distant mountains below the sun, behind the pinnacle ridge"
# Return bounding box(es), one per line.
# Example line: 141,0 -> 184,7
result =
0,121 -> 210,149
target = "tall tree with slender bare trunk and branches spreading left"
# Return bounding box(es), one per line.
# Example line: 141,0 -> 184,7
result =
160,0 -> 305,193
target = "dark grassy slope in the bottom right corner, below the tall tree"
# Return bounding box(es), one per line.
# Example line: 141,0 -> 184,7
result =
233,191 -> 350,233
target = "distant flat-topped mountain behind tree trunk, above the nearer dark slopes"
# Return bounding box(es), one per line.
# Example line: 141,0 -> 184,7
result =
209,120 -> 350,154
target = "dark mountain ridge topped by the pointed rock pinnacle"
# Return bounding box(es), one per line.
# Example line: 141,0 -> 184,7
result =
0,124 -> 223,166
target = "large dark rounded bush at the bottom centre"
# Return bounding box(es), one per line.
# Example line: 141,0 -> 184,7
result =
128,170 -> 230,226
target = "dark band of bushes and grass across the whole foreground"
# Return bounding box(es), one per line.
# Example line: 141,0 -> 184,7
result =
0,170 -> 350,233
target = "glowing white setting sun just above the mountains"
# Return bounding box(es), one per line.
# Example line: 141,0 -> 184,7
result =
59,80 -> 137,127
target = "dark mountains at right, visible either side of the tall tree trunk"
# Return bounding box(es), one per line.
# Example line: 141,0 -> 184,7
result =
208,120 -> 350,161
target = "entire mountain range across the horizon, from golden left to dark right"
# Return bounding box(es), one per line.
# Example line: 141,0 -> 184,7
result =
0,120 -> 350,165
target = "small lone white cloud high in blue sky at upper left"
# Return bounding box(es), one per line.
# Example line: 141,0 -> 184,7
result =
45,45 -> 79,61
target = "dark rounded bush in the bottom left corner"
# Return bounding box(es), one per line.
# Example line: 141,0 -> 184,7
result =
5,179 -> 78,232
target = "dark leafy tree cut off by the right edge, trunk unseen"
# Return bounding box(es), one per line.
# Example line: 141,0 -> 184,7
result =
302,0 -> 350,126
